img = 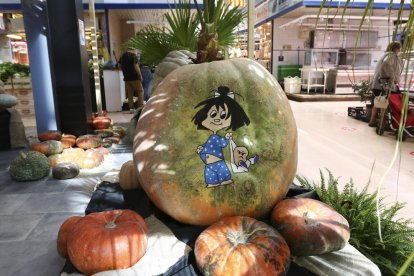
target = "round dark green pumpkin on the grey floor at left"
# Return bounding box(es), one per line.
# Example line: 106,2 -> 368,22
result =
9,151 -> 50,181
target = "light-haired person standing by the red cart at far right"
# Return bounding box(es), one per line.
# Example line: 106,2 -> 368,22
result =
368,42 -> 401,127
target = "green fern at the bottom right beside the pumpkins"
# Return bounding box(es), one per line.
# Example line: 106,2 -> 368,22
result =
296,170 -> 414,275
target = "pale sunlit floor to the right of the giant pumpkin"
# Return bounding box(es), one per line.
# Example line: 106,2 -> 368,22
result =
290,102 -> 414,219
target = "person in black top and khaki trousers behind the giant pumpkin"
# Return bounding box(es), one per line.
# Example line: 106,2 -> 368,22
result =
119,48 -> 144,113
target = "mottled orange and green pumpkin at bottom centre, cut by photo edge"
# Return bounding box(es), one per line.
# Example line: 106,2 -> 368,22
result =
194,216 -> 290,276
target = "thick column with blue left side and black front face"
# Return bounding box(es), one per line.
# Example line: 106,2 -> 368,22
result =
21,0 -> 92,135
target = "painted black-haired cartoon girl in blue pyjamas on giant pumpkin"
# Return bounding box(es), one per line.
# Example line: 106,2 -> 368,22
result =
192,86 -> 250,187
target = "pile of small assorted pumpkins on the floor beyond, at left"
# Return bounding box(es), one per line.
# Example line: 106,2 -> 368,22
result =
9,117 -> 125,181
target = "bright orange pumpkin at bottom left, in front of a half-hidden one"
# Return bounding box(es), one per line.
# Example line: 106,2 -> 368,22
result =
67,210 -> 149,275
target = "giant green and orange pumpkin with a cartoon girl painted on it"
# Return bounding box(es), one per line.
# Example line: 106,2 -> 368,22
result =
133,59 -> 297,225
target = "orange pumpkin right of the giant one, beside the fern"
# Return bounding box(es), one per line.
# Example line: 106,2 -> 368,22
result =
271,198 -> 350,256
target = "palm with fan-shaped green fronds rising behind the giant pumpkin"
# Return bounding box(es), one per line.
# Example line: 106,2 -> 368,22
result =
126,0 -> 245,64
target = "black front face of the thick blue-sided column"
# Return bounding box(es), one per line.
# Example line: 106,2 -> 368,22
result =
46,0 -> 92,135
